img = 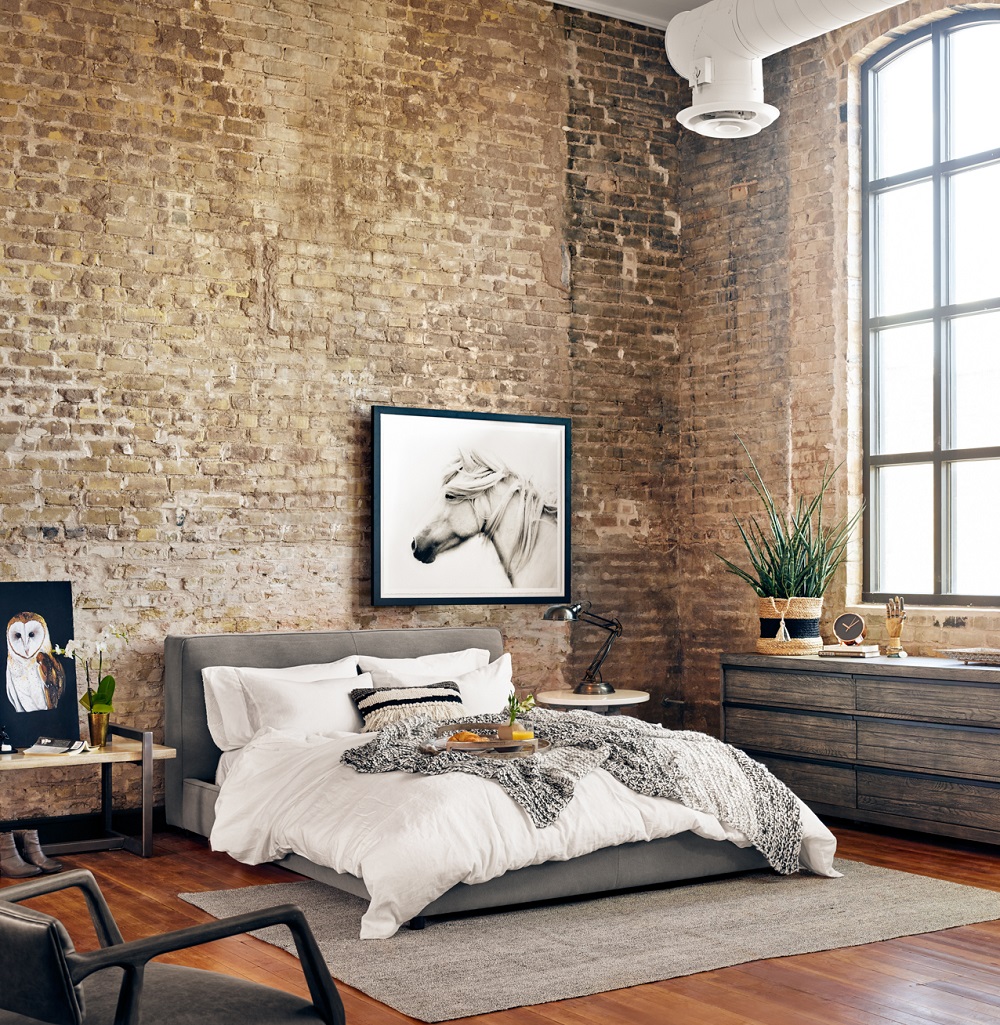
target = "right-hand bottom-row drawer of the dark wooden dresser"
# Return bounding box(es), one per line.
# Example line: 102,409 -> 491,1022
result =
858,769 -> 1000,830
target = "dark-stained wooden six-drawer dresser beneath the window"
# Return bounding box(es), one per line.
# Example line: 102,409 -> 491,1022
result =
722,654 -> 1000,844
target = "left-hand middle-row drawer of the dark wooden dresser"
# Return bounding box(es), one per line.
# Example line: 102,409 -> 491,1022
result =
725,708 -> 858,762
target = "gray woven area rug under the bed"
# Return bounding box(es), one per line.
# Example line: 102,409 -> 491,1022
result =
179,860 -> 1000,1022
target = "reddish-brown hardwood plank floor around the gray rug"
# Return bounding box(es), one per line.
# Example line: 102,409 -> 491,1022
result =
3,828 -> 1000,1025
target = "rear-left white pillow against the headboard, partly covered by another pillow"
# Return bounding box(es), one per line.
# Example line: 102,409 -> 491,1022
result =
202,655 -> 358,751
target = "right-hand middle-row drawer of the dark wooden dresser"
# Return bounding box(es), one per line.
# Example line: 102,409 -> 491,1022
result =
858,719 -> 1000,779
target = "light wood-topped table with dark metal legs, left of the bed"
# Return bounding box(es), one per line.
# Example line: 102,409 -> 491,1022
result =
0,723 -> 177,858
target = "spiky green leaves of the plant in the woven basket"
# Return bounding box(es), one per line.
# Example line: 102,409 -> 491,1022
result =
718,438 -> 862,598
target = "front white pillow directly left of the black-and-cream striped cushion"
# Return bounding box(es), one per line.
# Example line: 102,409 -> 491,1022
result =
247,672 -> 372,734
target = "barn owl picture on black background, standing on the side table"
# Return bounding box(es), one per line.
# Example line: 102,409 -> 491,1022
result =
0,580 -> 80,748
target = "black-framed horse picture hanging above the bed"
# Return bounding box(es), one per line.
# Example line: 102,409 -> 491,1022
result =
372,406 -> 572,605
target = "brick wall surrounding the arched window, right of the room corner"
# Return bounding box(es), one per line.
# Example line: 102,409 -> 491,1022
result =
678,0 -> 1000,730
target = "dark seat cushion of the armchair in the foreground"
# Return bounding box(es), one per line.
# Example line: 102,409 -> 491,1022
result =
0,962 -> 322,1025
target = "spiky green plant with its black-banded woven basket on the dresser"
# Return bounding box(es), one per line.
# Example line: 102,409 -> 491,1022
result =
718,438 -> 862,655
